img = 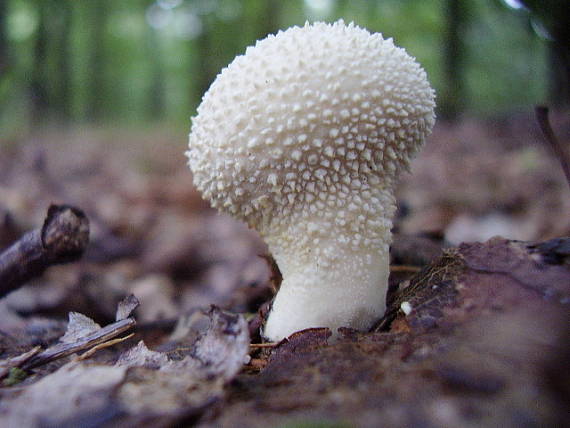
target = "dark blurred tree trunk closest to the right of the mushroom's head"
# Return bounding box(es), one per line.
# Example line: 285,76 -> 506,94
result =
440,0 -> 468,120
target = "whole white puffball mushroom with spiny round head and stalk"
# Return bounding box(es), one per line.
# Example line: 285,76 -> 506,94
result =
187,21 -> 435,341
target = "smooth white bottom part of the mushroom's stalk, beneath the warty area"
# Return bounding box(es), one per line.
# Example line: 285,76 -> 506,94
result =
264,250 -> 389,341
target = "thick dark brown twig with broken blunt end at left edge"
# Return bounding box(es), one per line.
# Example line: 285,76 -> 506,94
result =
0,205 -> 89,297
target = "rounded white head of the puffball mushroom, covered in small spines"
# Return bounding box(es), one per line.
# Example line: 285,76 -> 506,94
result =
187,21 -> 435,234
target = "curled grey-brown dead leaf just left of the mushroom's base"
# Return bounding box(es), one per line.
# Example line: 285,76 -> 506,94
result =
117,307 -> 249,414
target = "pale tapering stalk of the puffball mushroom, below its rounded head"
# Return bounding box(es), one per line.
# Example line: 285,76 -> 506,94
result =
264,189 -> 394,340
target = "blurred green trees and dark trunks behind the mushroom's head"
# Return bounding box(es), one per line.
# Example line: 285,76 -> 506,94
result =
0,0 -> 569,137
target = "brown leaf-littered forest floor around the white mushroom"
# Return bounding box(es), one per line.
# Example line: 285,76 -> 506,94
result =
0,113 -> 570,428
